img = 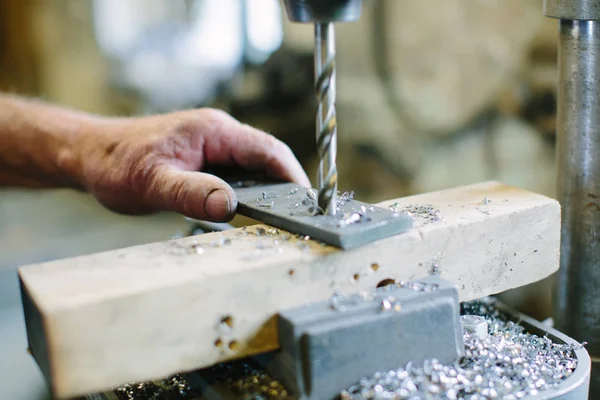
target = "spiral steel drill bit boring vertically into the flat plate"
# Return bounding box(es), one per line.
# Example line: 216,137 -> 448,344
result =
315,22 -> 338,215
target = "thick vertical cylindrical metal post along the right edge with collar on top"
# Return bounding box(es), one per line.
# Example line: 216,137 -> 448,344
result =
544,0 -> 600,398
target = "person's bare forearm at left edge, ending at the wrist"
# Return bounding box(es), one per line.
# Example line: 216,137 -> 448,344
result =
0,95 -> 96,187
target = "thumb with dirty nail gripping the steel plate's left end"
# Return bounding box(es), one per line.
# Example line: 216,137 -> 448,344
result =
145,165 -> 237,222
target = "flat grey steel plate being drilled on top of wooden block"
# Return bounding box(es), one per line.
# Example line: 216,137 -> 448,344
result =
233,183 -> 412,249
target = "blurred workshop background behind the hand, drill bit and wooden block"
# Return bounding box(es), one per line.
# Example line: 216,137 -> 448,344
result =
0,0 -> 557,397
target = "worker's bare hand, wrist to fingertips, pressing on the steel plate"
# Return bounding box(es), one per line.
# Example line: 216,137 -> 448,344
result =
73,109 -> 310,222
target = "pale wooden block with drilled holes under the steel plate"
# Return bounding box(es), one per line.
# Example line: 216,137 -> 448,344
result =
19,182 -> 560,397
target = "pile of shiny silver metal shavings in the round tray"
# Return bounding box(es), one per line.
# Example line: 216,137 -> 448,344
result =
341,301 -> 577,400
